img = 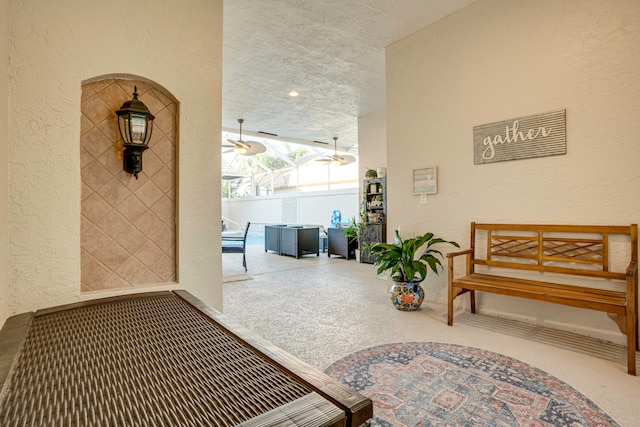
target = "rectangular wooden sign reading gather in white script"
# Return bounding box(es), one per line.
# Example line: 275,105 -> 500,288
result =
473,110 -> 567,165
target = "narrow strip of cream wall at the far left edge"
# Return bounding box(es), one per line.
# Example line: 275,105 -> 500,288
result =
0,0 -> 10,325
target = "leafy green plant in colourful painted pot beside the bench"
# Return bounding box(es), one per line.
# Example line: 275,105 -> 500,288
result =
369,230 -> 460,311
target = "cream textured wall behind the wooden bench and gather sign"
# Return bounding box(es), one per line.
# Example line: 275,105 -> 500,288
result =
387,0 -> 640,342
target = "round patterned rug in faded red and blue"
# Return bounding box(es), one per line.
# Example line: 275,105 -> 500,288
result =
325,342 -> 618,427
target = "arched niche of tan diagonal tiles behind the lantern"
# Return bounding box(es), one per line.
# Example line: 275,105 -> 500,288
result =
80,74 -> 178,293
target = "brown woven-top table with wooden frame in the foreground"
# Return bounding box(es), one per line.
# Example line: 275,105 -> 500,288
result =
0,291 -> 371,426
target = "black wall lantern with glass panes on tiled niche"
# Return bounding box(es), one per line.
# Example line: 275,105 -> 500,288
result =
116,86 -> 155,179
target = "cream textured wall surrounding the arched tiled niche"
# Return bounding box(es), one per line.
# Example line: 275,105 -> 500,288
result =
8,0 -> 222,313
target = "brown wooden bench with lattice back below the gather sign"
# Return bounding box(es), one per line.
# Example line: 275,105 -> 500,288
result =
447,222 -> 639,375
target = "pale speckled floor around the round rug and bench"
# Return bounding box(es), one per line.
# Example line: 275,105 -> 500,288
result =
222,244 -> 640,427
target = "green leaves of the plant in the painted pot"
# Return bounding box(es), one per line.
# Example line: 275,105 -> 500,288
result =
369,230 -> 460,282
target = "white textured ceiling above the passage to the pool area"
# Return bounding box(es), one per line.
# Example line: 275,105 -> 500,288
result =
222,0 -> 474,148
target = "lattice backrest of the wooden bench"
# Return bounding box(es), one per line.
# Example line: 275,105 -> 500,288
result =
471,222 -> 638,280
